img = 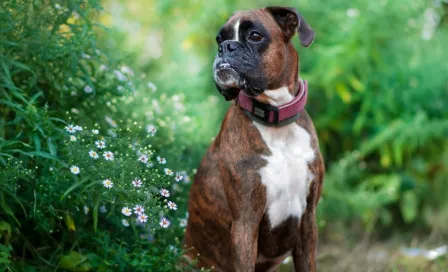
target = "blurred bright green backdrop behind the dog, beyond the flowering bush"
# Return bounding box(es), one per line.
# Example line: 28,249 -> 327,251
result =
101,0 -> 448,266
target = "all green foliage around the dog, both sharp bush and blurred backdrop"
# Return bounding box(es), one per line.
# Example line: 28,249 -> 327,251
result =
0,0 -> 448,271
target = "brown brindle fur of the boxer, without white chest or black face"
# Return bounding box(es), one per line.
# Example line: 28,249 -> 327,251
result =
184,6 -> 324,271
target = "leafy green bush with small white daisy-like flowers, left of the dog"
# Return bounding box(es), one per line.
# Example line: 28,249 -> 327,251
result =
0,0 -> 195,271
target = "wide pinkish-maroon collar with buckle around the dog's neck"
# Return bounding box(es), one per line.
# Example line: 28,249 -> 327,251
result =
235,80 -> 308,126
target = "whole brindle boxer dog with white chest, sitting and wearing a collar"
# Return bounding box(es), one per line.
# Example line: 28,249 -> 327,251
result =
184,7 -> 324,271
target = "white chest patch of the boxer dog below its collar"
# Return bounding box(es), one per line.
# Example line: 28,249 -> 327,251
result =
254,122 -> 315,228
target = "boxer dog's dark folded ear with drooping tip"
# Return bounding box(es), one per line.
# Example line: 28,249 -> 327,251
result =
266,7 -> 316,47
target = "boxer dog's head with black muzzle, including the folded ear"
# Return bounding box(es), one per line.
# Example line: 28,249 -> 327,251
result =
213,7 -> 315,100
